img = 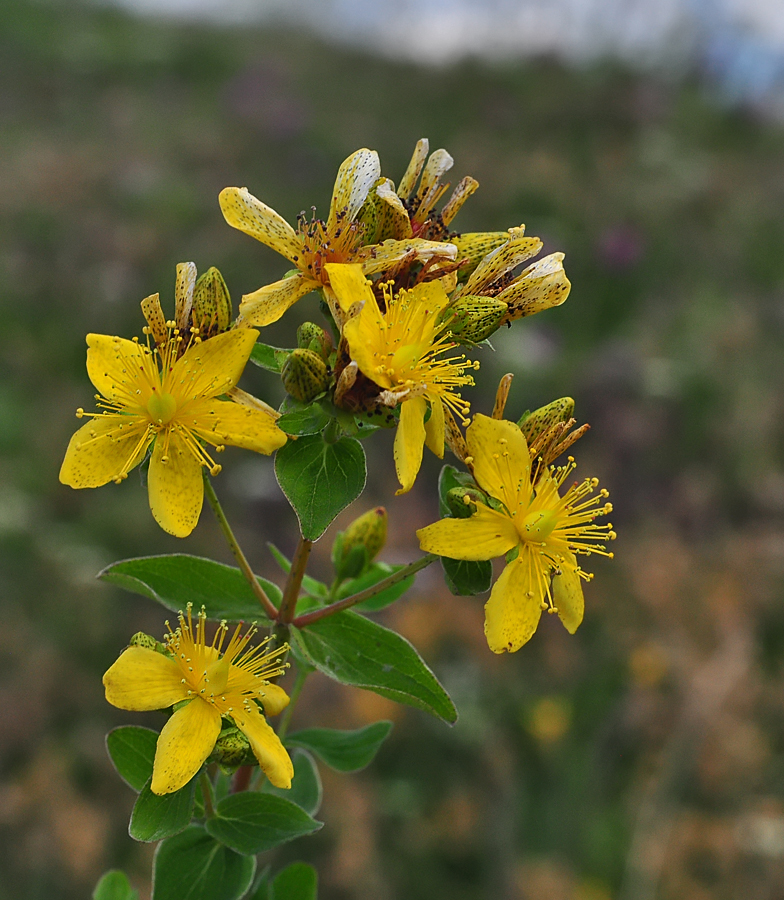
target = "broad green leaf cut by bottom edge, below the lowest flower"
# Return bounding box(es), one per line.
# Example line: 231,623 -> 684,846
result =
152,825 -> 256,900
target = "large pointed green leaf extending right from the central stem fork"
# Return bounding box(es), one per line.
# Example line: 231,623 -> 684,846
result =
291,610 -> 457,722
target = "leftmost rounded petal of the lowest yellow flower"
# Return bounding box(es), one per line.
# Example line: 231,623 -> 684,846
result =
103,647 -> 188,712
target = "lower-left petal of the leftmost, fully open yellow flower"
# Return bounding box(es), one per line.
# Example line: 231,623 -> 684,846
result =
60,416 -> 152,488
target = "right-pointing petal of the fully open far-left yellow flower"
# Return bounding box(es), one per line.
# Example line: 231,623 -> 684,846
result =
189,400 -> 286,455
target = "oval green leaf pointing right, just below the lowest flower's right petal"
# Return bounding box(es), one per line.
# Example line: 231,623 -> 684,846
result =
204,791 -> 324,854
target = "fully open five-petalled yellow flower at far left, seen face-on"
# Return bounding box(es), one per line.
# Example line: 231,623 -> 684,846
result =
60,324 -> 286,537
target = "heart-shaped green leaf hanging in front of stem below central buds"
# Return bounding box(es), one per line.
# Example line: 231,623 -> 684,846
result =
275,434 -> 367,541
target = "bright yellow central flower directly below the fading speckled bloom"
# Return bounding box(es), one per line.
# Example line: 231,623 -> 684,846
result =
327,265 -> 479,494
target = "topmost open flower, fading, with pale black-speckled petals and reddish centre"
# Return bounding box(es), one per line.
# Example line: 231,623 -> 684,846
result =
219,149 -> 457,325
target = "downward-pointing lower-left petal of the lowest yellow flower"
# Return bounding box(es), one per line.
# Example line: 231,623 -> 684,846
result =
150,697 -> 220,794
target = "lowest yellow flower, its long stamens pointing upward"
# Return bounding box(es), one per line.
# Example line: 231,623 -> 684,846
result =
103,604 -> 294,794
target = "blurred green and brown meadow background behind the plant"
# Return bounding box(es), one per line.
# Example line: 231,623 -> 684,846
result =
0,0 -> 784,900
